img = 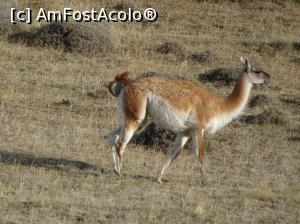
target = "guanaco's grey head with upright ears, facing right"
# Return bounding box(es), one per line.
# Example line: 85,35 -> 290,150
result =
241,57 -> 271,84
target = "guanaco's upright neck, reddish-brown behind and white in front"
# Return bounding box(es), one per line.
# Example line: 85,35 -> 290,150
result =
224,72 -> 252,113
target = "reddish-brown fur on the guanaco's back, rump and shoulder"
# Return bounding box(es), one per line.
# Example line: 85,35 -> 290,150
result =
119,76 -> 225,127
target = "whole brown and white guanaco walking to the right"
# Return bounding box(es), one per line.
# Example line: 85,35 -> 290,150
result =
107,58 -> 271,184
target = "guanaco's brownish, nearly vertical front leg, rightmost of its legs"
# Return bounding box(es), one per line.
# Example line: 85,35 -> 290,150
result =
193,129 -> 207,184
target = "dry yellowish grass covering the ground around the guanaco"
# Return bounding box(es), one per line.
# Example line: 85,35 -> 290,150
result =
0,0 -> 300,223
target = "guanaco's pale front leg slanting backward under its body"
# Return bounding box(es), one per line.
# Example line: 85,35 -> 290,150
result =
157,135 -> 189,183
